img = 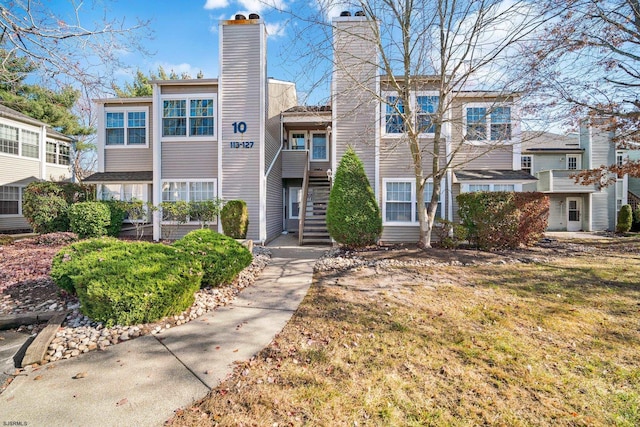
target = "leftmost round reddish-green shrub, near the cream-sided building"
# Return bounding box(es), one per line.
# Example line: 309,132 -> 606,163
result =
22,181 -> 69,234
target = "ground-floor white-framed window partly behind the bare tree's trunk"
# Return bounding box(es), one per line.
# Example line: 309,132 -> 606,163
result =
382,178 -> 442,225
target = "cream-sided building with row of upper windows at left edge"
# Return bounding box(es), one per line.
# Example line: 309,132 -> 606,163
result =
0,105 -> 72,232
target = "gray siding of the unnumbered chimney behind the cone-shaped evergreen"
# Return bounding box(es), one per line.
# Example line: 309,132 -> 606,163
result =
332,20 -> 380,184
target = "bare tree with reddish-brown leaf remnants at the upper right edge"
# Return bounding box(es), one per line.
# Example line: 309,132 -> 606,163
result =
530,0 -> 640,184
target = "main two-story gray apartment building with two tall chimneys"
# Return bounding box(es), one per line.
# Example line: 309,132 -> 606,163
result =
85,15 -> 535,243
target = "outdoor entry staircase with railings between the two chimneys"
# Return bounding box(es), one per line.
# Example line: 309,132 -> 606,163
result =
299,172 -> 331,245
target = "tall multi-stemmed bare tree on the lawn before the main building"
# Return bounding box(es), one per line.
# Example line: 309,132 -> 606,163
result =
282,0 -> 550,247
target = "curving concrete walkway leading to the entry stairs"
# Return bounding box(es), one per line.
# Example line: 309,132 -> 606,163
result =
0,236 -> 327,426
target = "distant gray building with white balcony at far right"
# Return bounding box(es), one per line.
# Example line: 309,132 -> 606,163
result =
521,126 -> 628,231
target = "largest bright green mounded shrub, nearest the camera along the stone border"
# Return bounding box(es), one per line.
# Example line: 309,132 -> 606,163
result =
52,239 -> 202,326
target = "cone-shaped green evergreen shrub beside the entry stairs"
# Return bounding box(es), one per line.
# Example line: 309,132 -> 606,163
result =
327,148 -> 382,248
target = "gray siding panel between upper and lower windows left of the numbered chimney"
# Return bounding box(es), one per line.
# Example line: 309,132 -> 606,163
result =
162,140 -> 218,179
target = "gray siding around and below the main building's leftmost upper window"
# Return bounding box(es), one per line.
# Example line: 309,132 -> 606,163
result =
104,102 -> 154,172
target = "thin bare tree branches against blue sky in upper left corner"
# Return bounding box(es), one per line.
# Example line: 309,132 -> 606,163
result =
0,0 -> 149,90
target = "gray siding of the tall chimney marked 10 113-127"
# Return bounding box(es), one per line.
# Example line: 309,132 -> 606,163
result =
219,24 -> 266,240
